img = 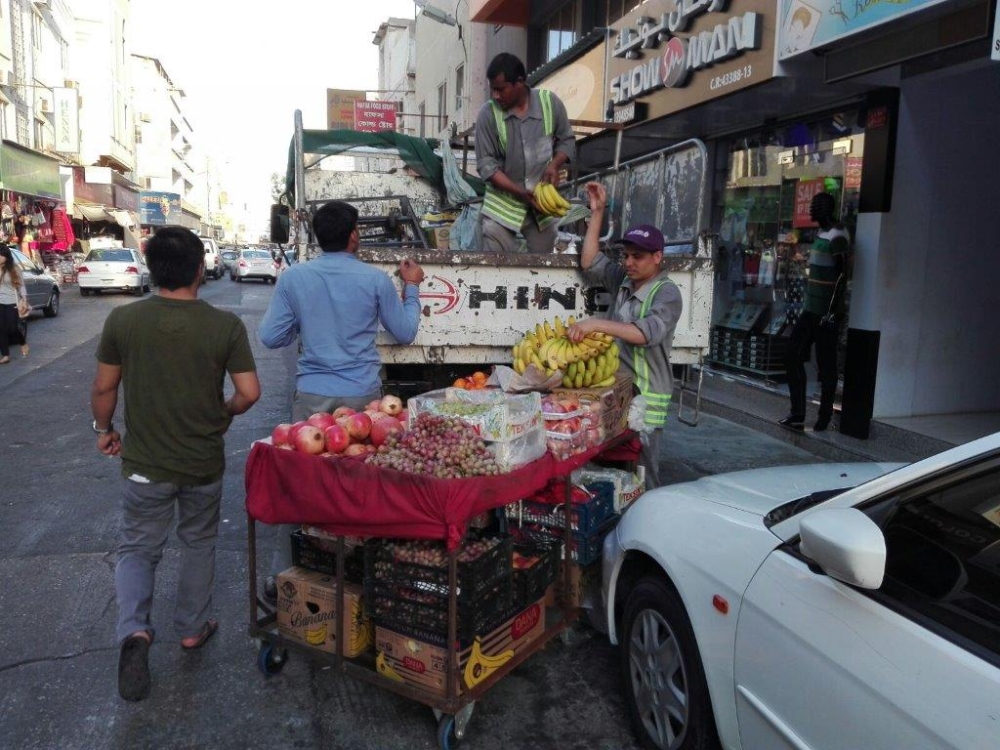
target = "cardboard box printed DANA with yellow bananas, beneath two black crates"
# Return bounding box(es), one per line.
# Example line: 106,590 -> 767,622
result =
375,600 -> 545,696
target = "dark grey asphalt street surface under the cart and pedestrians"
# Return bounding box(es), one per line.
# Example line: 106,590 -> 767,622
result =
0,279 -> 818,750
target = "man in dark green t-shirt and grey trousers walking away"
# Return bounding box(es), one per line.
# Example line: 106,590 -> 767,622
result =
90,227 -> 260,701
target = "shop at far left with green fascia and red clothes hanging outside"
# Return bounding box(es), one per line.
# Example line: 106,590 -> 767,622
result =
0,141 -> 73,266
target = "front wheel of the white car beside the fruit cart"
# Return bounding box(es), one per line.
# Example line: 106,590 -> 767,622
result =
621,577 -> 719,750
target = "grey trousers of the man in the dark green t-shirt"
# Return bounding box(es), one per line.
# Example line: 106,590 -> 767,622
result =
115,479 -> 222,642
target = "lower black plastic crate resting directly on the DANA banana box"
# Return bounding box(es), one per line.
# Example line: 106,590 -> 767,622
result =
365,578 -> 512,645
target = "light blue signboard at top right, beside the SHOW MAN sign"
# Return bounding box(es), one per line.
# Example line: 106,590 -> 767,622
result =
778,0 -> 947,60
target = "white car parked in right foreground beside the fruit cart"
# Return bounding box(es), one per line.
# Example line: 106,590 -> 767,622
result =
602,433 -> 1000,750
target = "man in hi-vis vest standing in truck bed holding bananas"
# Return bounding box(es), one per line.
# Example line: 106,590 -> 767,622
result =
476,52 -> 576,253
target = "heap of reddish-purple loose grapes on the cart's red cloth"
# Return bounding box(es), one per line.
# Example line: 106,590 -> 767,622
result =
365,412 -> 501,479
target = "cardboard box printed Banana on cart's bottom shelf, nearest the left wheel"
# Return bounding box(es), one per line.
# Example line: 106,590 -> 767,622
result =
278,567 -> 374,657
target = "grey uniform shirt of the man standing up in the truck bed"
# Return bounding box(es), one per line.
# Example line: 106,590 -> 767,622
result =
476,89 -> 576,190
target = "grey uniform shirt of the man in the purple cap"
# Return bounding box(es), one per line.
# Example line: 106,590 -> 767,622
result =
584,253 -> 684,394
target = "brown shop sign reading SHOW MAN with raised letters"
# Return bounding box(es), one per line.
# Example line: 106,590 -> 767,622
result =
608,0 -> 776,125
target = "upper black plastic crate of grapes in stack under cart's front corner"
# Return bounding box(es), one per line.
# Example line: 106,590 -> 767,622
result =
365,534 -> 513,597
